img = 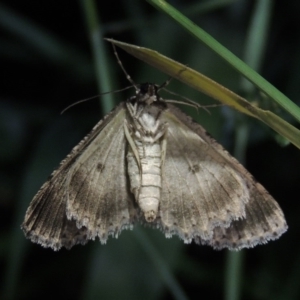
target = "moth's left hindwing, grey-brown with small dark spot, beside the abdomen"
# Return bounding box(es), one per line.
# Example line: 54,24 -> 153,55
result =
67,104 -> 135,243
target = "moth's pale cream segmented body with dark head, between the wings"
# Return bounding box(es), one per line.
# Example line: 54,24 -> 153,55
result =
125,88 -> 166,222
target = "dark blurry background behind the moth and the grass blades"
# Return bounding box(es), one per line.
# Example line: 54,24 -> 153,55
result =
0,0 -> 300,300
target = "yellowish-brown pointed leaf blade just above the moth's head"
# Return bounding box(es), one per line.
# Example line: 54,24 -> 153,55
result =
106,39 -> 300,148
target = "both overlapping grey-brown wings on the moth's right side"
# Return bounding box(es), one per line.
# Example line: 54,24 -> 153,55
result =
157,104 -> 287,249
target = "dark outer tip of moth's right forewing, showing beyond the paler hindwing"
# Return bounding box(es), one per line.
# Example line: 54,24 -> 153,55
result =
195,182 -> 287,250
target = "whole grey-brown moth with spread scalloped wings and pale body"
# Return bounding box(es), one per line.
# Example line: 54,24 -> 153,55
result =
22,84 -> 287,250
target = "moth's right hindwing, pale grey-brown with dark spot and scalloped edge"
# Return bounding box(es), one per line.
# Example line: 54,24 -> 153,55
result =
160,105 -> 249,242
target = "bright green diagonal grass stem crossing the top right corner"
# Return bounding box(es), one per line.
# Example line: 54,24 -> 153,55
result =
147,0 -> 300,121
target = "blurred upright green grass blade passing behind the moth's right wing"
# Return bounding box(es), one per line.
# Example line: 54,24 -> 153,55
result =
224,0 -> 272,300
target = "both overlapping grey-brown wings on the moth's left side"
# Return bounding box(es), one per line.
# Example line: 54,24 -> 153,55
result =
22,103 -> 135,250
